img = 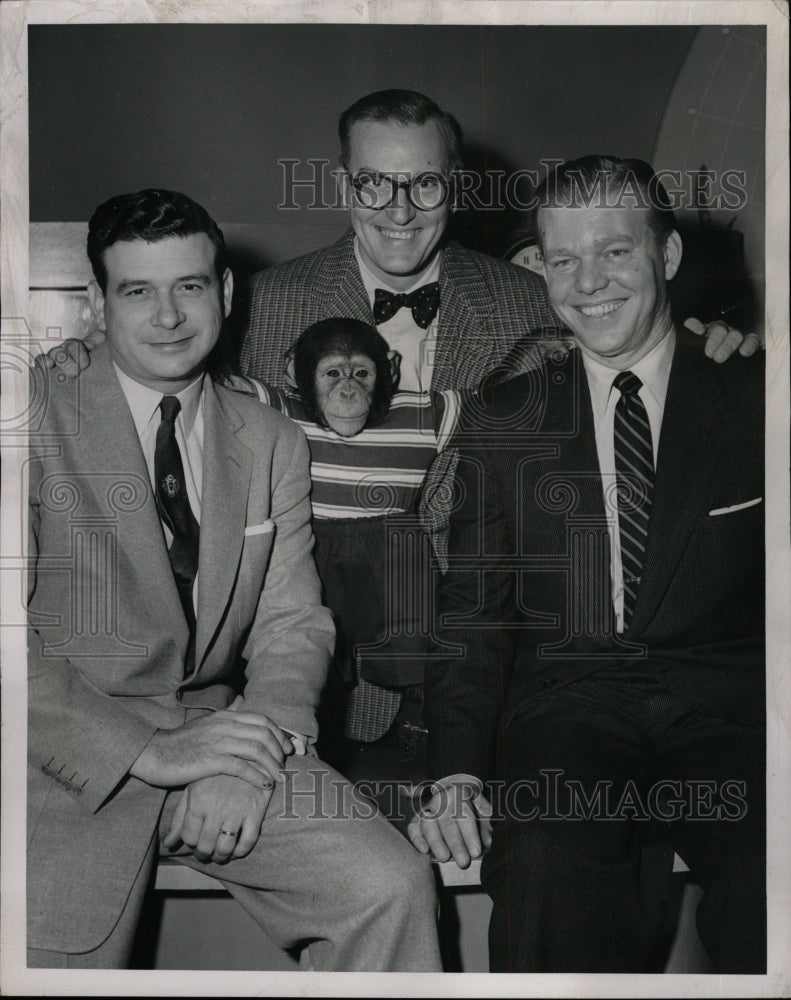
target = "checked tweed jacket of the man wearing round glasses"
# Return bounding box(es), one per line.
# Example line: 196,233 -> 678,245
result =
241,230 -> 558,568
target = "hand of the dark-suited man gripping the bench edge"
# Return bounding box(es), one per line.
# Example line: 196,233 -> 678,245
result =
407,775 -> 492,868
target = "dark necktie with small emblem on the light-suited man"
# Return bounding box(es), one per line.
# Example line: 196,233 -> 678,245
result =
154,396 -> 200,672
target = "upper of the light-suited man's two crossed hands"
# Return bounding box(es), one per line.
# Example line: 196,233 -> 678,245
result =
129,699 -> 294,789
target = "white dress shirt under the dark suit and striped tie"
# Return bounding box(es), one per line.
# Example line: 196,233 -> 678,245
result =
580,330 -> 676,632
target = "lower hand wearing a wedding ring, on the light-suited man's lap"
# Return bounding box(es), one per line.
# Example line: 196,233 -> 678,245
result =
163,775 -> 272,864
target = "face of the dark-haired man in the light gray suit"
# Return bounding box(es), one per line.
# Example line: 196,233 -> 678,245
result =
88,233 -> 233,394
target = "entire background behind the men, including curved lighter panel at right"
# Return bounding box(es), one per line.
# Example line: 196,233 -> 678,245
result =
29,24 -> 766,335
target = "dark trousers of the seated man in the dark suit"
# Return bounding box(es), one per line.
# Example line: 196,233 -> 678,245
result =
482,667 -> 766,974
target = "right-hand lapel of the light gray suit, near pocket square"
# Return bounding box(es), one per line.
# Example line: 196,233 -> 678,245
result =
195,378 -> 252,669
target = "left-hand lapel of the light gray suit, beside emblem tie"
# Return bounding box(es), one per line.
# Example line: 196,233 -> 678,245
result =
76,347 -> 187,645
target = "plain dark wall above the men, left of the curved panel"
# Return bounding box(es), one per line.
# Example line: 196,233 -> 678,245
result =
29,24 -> 696,266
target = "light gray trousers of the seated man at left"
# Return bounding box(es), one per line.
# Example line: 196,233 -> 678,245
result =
28,755 -> 442,972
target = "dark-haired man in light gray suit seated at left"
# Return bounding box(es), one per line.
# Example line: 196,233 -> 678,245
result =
27,190 -> 440,971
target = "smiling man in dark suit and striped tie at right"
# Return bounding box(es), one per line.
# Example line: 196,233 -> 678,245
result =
410,157 -> 766,973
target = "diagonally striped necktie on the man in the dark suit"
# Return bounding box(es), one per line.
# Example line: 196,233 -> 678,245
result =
613,372 -> 654,628
